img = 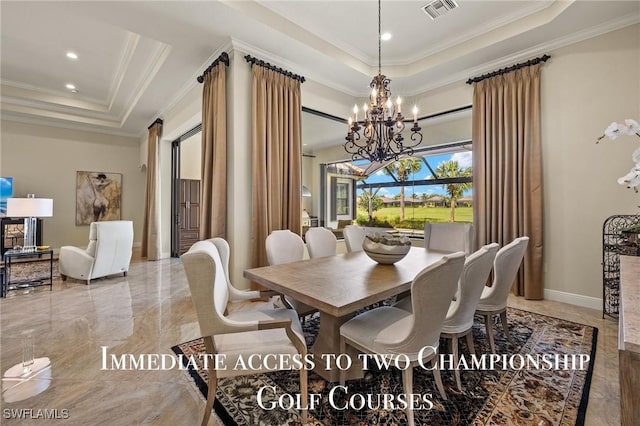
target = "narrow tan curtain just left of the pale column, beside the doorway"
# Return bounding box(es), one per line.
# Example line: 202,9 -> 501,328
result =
200,62 -> 227,240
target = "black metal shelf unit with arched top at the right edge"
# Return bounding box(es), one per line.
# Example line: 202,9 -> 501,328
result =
602,215 -> 640,318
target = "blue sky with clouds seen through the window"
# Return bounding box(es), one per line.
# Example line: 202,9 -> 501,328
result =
356,151 -> 472,198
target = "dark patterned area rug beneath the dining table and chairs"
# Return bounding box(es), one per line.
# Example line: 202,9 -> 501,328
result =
172,308 -> 598,426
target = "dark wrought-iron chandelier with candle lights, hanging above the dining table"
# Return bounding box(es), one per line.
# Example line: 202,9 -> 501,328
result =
344,0 -> 422,162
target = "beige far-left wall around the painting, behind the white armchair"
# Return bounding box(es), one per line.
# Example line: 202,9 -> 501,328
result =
0,121 -> 145,249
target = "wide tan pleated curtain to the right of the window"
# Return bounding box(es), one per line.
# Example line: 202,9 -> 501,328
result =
472,64 -> 544,299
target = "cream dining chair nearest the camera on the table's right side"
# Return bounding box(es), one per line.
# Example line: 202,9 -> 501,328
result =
340,252 -> 464,426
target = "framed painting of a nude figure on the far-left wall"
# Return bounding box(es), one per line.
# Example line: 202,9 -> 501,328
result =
76,172 -> 122,225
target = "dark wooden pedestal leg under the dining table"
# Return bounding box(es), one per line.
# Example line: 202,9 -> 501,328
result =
311,312 -> 364,382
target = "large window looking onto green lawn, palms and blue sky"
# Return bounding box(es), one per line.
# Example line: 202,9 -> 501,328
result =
338,141 -> 473,234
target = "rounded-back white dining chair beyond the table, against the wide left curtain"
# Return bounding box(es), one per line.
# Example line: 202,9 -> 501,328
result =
265,229 -> 317,317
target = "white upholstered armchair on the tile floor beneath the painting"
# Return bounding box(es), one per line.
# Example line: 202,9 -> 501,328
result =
58,220 -> 133,284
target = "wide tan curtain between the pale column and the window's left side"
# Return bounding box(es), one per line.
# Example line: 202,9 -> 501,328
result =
251,66 -> 302,267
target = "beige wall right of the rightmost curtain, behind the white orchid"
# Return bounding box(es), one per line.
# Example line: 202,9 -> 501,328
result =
541,25 -> 640,307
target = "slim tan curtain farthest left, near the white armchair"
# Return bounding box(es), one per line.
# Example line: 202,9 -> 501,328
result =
142,120 -> 162,260
